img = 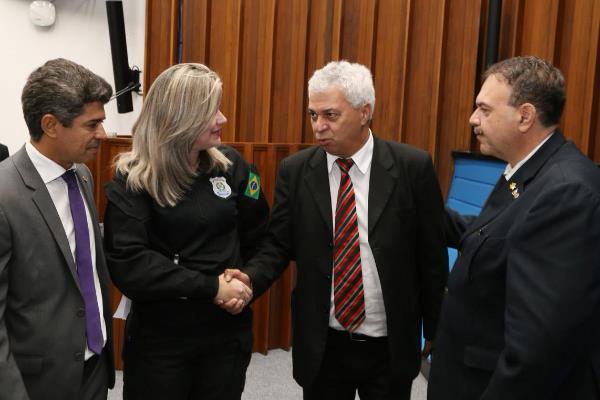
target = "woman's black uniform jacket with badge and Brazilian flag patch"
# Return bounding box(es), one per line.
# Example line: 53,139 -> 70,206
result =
104,146 -> 269,338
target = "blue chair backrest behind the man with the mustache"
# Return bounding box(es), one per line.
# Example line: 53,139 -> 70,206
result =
446,151 -> 506,269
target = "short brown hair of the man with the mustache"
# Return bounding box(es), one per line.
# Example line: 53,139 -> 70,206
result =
483,56 -> 566,126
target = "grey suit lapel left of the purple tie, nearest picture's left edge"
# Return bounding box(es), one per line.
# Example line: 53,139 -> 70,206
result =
13,147 -> 79,285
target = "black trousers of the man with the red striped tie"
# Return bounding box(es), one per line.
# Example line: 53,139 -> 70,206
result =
303,329 -> 412,400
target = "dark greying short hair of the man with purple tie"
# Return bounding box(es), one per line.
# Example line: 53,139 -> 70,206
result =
21,58 -> 112,141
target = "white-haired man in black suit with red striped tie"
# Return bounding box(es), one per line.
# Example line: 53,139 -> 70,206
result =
224,61 -> 448,400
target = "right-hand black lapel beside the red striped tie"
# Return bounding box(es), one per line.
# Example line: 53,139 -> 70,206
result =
369,136 -> 398,236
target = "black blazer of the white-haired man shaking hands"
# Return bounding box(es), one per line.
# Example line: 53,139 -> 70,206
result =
246,138 -> 448,386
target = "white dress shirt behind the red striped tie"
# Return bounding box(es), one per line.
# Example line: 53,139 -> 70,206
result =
327,130 -> 387,337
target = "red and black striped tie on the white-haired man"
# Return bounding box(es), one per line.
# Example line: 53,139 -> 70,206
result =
333,158 -> 365,332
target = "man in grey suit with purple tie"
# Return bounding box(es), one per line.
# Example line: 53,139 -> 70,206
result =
0,59 -> 114,400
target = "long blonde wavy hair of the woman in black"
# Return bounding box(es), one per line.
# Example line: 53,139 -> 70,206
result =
115,63 -> 231,207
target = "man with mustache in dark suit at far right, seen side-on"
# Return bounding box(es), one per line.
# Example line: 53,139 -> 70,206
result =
428,57 -> 600,400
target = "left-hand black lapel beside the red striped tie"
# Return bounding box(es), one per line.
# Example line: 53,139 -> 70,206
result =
304,148 -> 333,231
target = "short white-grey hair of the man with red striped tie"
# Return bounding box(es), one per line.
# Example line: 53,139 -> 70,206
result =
308,60 -> 375,119
